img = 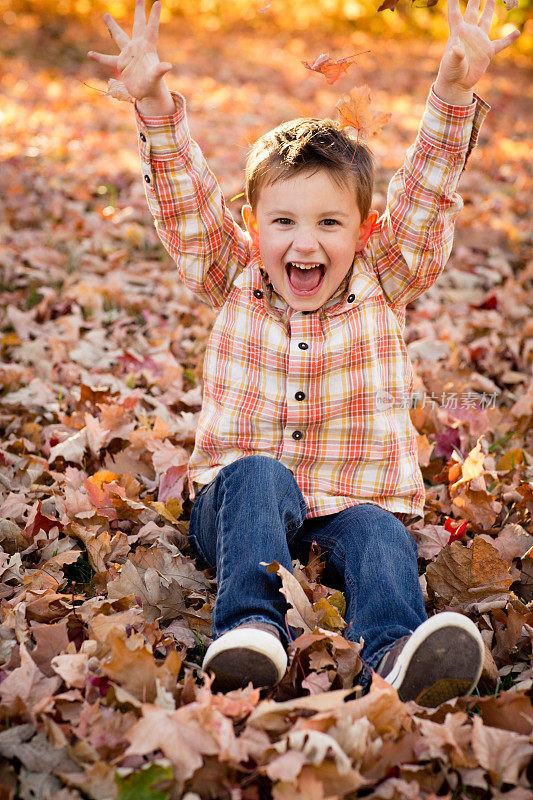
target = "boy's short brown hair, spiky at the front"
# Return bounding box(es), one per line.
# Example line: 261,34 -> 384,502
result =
246,117 -> 374,221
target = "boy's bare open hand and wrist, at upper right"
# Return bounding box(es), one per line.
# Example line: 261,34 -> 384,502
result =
434,0 -> 520,105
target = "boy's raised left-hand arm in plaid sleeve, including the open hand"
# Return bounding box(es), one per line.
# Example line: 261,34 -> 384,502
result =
89,0 -> 251,308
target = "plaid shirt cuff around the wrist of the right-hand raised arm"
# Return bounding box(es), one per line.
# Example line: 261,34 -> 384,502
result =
420,85 -> 490,168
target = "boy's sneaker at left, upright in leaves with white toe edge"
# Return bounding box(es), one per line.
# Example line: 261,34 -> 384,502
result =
202,622 -> 287,692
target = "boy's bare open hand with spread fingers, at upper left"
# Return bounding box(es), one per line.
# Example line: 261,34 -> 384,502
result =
87,0 -> 175,113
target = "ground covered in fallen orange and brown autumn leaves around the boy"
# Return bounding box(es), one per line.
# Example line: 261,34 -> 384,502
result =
0,6 -> 533,800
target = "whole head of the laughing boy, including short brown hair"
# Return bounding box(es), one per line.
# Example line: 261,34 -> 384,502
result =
242,126 -> 377,311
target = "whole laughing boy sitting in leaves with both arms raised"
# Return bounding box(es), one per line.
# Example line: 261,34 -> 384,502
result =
89,0 -> 519,705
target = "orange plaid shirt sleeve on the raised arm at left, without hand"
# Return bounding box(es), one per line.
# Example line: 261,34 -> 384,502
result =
135,92 -> 251,308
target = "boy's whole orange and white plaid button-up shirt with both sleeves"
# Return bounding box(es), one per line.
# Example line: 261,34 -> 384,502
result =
135,89 -> 489,518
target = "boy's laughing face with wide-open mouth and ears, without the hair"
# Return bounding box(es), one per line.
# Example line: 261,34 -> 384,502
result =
242,170 -> 377,311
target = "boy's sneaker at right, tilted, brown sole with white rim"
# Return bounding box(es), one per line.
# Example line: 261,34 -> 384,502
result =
376,611 -> 485,707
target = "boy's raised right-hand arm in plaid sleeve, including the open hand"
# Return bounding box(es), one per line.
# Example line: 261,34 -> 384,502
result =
370,0 -> 520,305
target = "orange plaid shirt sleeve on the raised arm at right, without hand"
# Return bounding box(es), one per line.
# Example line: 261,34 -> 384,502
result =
369,86 -> 490,306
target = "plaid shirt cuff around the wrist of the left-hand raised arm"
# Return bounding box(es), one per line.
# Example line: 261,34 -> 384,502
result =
134,92 -> 190,162
